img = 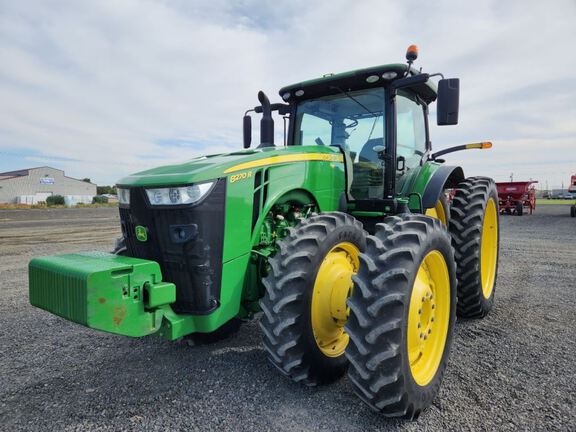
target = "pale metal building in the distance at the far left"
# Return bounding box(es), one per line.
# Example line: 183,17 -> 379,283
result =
0,167 -> 96,204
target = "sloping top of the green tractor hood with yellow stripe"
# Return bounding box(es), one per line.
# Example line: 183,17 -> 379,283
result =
117,146 -> 340,187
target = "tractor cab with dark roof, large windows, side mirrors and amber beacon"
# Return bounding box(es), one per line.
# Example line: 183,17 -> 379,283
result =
245,46 -> 459,213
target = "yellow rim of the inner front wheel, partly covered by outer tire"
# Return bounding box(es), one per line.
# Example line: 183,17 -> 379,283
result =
312,242 -> 360,357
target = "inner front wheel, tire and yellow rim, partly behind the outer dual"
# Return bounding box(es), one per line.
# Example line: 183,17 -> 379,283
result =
260,212 -> 366,386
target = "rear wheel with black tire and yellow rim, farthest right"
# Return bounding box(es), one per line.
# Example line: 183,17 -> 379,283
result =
450,177 -> 500,318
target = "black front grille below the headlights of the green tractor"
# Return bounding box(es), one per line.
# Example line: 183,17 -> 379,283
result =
120,179 -> 226,314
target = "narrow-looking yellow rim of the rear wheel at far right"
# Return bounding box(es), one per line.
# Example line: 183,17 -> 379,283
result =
480,198 -> 498,298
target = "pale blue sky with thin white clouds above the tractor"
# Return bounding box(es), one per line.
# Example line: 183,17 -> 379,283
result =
0,0 -> 576,188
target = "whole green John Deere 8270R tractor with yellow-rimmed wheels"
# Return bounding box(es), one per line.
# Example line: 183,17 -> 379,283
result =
29,46 -> 499,419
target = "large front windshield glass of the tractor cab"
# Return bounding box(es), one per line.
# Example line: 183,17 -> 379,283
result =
294,88 -> 384,199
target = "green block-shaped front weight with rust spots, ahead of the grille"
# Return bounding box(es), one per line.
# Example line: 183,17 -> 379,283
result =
28,252 -> 176,337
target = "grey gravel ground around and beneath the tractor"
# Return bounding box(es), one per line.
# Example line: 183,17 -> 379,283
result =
0,205 -> 576,431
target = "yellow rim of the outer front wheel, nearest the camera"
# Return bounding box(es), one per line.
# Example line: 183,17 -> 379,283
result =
408,250 -> 450,386
